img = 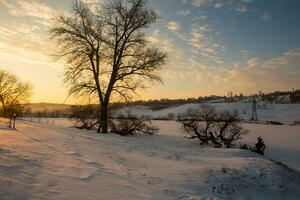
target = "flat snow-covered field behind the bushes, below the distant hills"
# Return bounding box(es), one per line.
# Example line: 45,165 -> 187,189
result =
19,114 -> 300,171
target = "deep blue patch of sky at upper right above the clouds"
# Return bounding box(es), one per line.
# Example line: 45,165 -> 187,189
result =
150,0 -> 300,61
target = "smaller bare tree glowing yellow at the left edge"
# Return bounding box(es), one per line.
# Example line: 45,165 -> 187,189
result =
0,70 -> 32,125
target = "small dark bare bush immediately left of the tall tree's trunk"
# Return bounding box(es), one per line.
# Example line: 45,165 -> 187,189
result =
70,105 -> 100,130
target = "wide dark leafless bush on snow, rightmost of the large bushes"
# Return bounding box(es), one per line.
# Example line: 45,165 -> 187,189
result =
179,105 -> 249,147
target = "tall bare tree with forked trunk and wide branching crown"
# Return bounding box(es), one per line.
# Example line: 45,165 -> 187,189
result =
50,0 -> 166,133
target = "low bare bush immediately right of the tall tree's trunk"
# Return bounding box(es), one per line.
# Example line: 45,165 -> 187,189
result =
110,115 -> 159,136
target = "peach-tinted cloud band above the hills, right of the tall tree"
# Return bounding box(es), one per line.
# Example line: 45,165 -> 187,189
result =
152,43 -> 300,96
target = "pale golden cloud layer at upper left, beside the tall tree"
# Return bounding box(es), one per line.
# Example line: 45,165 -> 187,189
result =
0,0 -> 70,70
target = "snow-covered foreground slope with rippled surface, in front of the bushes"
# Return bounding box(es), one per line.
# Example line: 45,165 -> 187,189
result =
0,119 -> 300,200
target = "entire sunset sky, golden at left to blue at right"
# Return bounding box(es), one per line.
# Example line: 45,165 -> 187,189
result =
0,0 -> 300,103
